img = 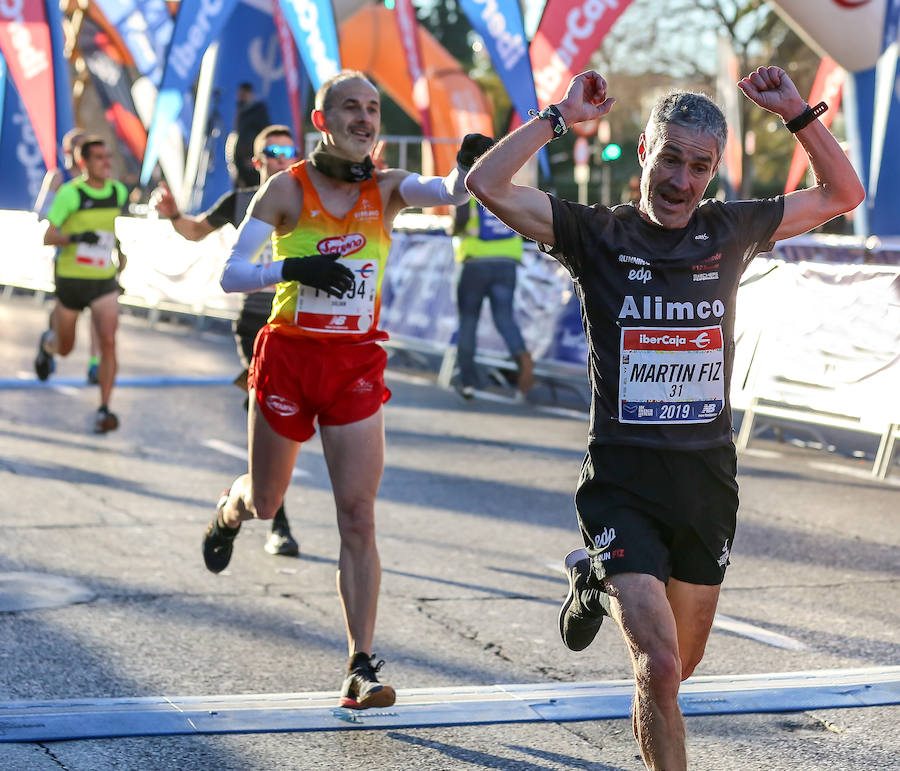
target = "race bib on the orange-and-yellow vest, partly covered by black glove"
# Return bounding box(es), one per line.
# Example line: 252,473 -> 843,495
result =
294,258 -> 378,334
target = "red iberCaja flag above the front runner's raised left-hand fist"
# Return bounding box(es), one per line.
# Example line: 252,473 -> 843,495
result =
530,0 -> 631,106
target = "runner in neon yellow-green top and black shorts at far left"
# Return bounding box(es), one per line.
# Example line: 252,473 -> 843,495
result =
34,137 -> 128,434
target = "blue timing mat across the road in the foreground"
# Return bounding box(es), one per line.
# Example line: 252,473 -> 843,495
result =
0,667 -> 900,742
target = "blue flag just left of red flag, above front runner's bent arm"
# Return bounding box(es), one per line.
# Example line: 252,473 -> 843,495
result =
458,0 -> 550,178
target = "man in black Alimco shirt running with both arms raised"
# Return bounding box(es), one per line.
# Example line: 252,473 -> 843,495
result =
466,67 -> 864,771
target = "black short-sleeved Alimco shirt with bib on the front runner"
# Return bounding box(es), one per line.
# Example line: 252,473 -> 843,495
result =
549,195 -> 784,450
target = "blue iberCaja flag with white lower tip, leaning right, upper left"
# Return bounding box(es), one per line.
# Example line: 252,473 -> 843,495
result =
141,0 -> 237,185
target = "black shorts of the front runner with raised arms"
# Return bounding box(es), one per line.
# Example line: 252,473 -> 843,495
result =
575,445 -> 738,586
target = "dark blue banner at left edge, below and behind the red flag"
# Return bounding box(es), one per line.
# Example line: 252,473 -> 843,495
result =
0,55 -> 47,211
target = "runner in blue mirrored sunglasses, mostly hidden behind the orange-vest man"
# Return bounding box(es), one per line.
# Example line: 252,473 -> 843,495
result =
153,124 -> 300,557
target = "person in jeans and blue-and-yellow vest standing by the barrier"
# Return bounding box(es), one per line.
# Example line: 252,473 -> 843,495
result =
453,198 -> 534,399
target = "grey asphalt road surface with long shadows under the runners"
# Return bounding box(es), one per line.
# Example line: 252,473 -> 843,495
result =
0,295 -> 900,771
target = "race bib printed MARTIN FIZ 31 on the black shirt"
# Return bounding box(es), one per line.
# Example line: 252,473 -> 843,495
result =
619,326 -> 725,424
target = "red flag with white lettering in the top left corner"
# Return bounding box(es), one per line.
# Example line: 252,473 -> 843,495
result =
0,0 -> 56,169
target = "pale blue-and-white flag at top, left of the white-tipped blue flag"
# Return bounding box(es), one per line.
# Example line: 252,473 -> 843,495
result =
91,0 -> 175,86
